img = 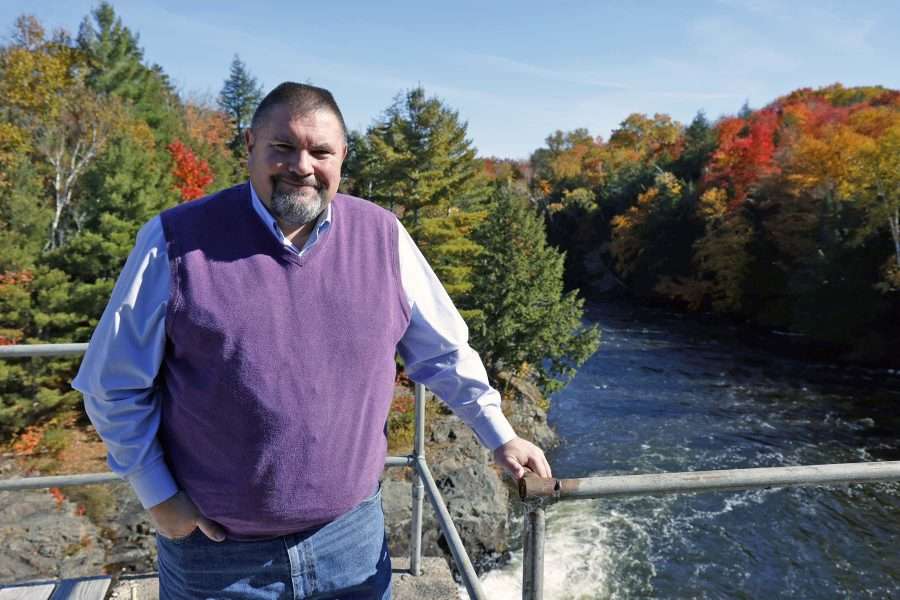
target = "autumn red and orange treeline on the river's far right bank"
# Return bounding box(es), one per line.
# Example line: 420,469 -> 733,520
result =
516,84 -> 900,364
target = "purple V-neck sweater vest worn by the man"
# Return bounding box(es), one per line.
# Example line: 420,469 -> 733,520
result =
159,183 -> 409,539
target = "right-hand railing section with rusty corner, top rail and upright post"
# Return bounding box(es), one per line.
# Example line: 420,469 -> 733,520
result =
519,461 -> 900,600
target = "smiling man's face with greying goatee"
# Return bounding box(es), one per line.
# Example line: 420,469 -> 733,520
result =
245,105 -> 347,227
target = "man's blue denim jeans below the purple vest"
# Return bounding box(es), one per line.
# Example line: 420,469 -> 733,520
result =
156,487 -> 391,600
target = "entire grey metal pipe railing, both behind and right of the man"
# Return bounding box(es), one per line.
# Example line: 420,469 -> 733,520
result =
14,344 -> 900,600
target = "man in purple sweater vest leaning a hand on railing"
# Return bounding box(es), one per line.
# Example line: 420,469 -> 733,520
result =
73,83 -> 550,598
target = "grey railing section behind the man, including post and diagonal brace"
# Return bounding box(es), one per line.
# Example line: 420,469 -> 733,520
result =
0,344 -> 487,600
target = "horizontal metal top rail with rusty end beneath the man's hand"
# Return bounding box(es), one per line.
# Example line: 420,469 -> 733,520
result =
519,461 -> 900,500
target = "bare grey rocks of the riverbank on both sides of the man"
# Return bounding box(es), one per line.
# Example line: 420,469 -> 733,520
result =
0,378 -> 556,583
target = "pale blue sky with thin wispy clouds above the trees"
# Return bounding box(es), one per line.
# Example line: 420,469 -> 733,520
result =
0,0 -> 900,158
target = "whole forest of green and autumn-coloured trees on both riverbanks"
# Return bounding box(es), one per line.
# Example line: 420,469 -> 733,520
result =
0,3 -> 900,448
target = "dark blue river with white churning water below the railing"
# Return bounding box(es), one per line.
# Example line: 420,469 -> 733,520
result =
474,304 -> 900,600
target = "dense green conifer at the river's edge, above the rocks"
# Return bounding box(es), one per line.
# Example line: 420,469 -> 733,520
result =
471,186 -> 599,394
